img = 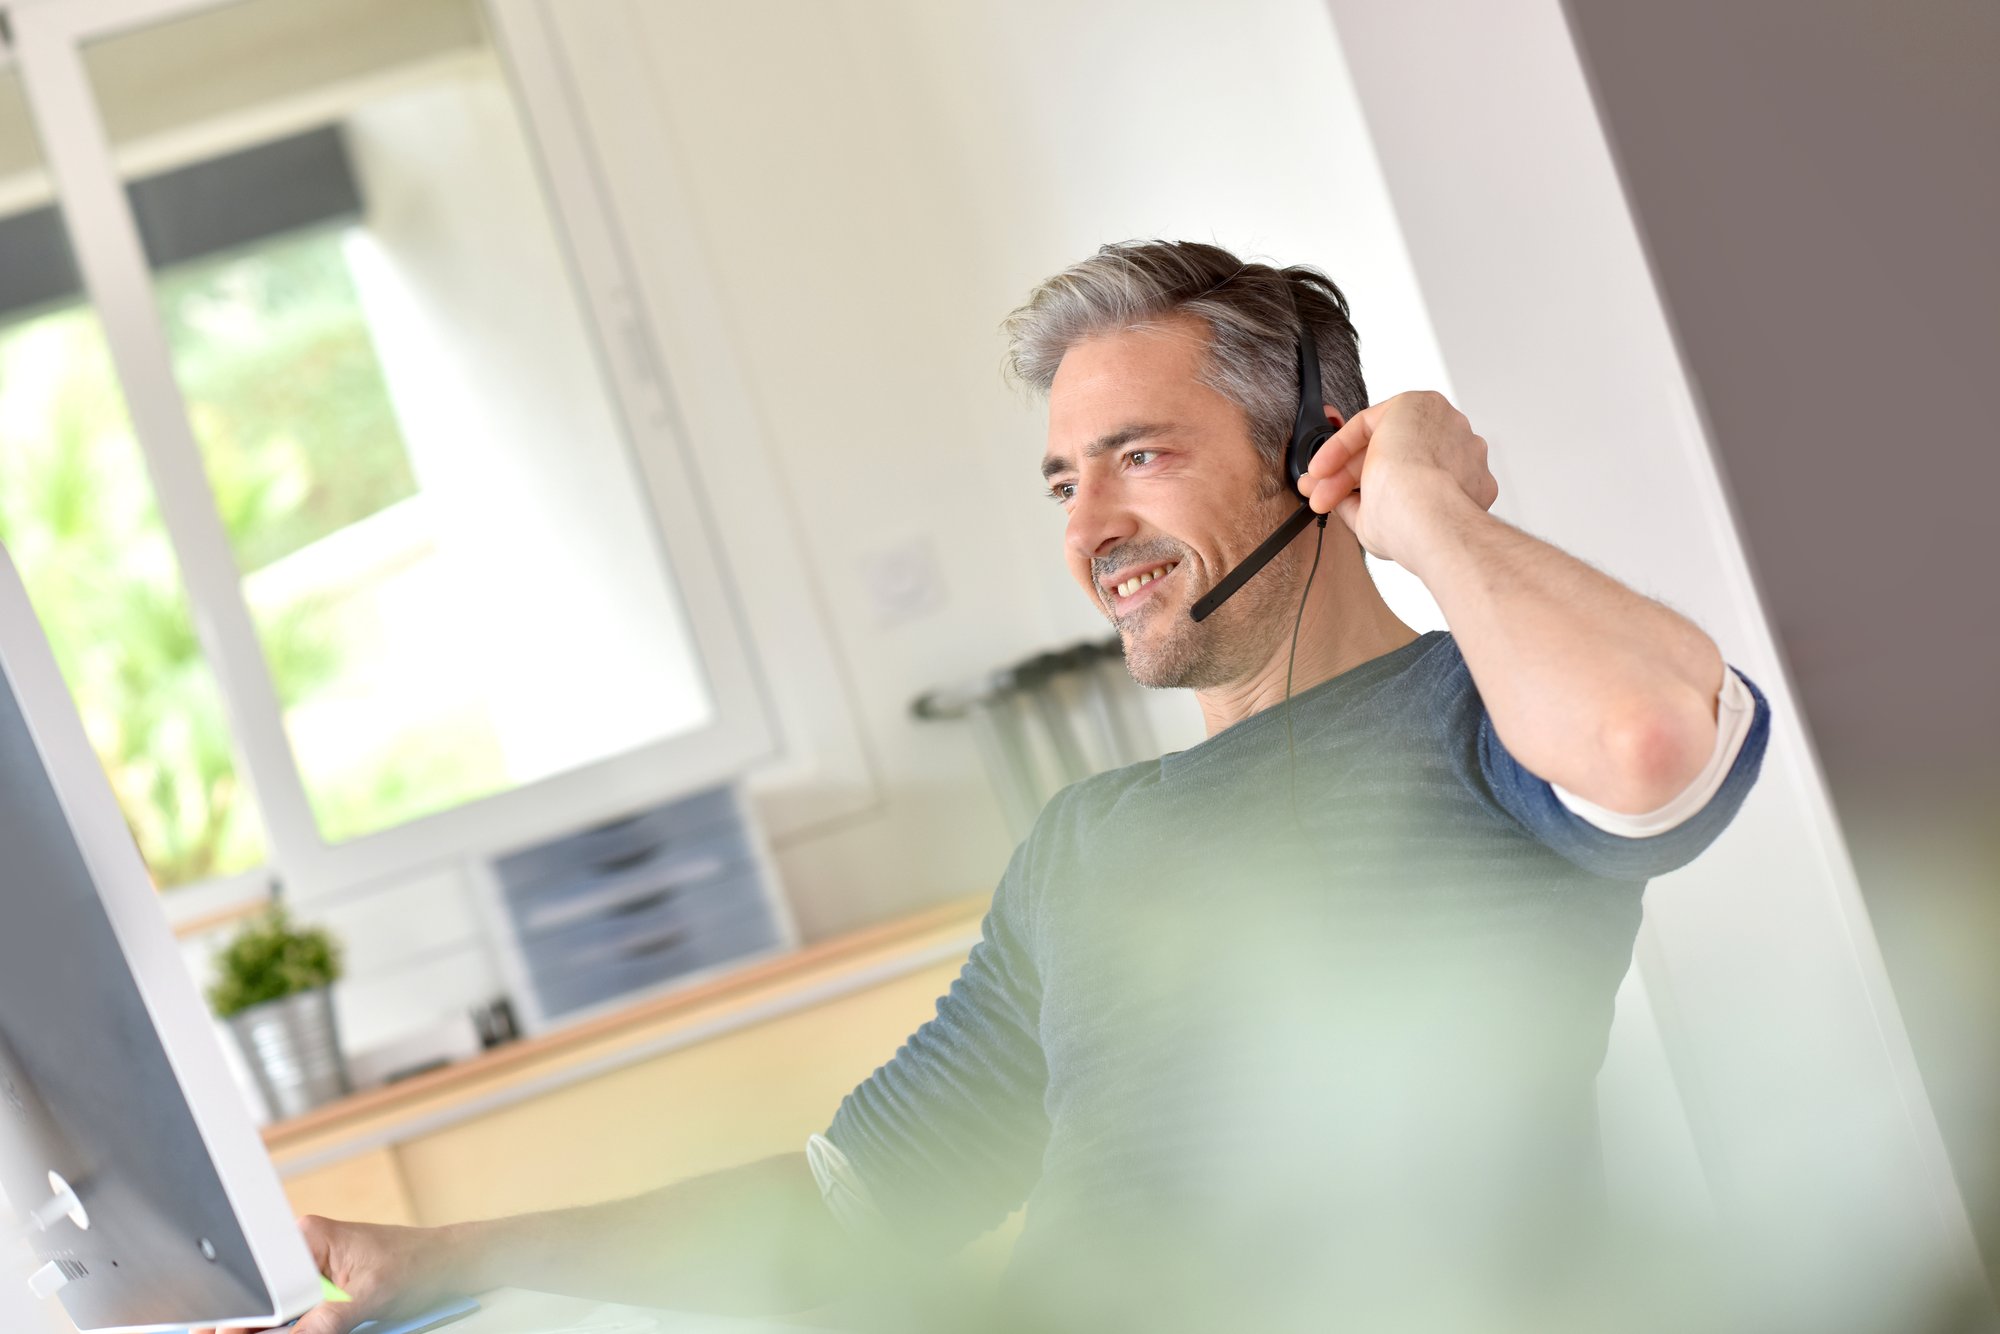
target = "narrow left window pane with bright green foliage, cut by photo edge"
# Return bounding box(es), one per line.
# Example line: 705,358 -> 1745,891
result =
0,70 -> 266,888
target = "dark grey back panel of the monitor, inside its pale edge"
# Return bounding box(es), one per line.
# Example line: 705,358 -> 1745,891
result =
0,662 -> 270,1330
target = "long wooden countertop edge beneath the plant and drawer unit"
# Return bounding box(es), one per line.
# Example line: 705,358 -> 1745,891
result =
264,894 -> 988,1176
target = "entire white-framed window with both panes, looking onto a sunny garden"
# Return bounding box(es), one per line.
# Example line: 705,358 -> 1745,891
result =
0,0 -> 768,908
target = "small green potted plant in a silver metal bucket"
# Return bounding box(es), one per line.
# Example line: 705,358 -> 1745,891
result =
208,904 -> 350,1120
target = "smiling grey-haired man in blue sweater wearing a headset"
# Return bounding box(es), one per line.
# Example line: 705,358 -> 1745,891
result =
207,242 -> 1768,1334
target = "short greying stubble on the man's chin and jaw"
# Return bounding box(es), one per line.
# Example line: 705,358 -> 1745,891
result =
1112,490 -> 1300,690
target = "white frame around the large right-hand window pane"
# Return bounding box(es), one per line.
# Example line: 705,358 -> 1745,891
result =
4,0 -> 778,922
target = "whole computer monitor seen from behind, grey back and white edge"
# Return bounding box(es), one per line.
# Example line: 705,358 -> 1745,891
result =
0,550 -> 320,1330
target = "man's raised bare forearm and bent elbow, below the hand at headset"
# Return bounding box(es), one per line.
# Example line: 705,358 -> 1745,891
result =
1408,494 -> 1722,812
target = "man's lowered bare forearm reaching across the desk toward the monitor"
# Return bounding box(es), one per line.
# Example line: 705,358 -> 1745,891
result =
438,1154 -> 856,1314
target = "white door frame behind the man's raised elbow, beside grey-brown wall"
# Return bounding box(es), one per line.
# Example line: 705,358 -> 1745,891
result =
1328,0 -> 1984,1328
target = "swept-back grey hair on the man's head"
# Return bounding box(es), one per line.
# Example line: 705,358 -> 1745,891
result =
1000,240 -> 1368,474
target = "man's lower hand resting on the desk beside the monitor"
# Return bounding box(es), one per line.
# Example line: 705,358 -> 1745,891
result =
190,1214 -> 462,1334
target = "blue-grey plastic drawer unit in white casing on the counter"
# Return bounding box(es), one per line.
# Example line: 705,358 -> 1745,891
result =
482,788 -> 796,1032
